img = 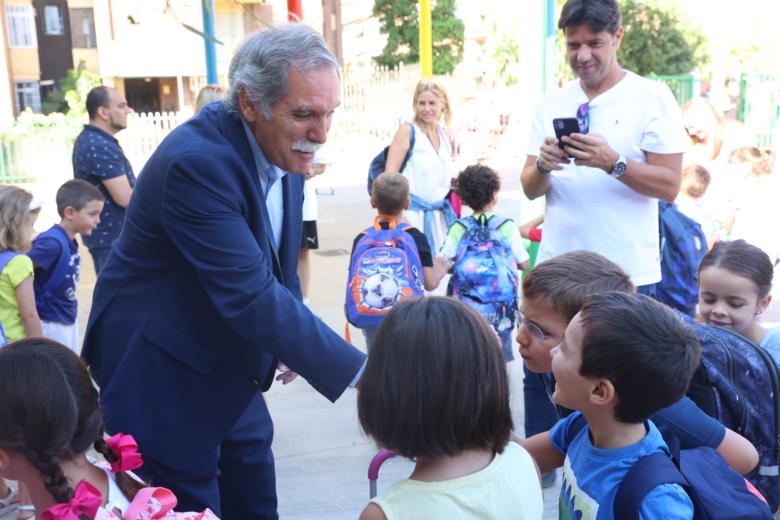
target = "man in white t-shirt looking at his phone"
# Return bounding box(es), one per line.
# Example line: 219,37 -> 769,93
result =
522,0 -> 686,293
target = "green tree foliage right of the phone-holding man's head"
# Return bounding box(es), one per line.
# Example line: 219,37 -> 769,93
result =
618,0 -> 709,76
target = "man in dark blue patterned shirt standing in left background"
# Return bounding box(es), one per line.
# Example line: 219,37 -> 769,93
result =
73,86 -> 135,273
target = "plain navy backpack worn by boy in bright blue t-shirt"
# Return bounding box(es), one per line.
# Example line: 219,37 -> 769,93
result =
567,416 -> 772,520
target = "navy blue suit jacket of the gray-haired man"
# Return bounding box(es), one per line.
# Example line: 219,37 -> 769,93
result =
82,103 -> 365,471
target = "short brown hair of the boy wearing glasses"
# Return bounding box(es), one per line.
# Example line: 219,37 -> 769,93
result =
523,251 -> 634,322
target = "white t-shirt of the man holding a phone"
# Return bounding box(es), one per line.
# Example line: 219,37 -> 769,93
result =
528,71 -> 687,285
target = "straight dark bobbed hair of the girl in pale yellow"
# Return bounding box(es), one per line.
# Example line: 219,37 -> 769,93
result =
358,297 -> 512,457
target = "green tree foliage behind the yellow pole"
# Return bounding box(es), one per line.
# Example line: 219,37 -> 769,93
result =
374,0 -> 464,74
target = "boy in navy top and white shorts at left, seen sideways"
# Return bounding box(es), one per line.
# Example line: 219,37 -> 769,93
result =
27,179 -> 105,353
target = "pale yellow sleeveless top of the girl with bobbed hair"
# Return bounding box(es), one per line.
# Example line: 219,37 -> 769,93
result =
371,442 -> 544,520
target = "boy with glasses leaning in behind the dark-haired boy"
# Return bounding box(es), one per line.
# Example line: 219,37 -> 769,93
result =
517,251 -> 758,474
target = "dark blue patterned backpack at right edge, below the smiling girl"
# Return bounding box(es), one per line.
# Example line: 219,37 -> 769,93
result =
684,316 -> 780,511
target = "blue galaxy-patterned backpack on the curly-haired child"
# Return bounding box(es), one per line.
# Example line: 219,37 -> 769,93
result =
450,214 -> 518,303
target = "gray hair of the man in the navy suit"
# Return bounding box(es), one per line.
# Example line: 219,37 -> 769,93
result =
225,23 -> 339,119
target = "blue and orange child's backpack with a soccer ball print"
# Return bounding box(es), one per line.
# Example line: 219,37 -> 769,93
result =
346,217 -> 424,329
